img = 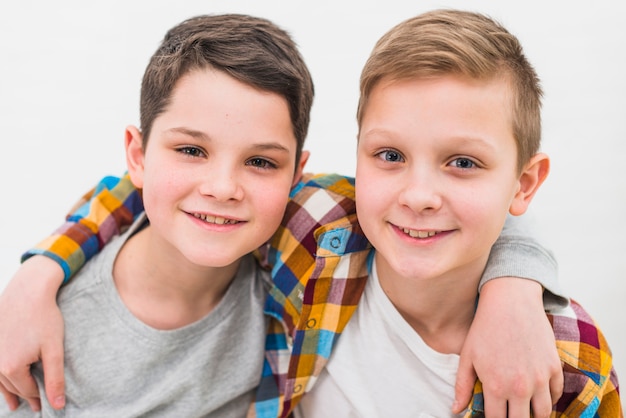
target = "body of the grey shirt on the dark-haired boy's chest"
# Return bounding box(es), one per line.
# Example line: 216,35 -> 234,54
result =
0,219 -> 269,418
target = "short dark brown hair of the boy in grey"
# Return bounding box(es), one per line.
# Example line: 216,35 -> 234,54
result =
140,14 -> 314,163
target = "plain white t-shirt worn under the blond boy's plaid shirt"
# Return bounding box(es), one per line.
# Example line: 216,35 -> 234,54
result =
297,258 -> 459,418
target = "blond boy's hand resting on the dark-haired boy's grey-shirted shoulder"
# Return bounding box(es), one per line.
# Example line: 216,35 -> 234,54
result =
0,256 -> 65,411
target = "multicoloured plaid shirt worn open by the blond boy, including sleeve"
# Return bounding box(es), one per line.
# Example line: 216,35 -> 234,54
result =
24,175 -> 623,417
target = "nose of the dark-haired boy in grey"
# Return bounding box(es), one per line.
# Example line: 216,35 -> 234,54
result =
199,162 -> 244,202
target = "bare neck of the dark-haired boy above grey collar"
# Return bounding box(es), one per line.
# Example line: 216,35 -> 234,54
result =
113,226 -> 239,330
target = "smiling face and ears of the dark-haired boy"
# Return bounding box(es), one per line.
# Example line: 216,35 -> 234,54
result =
127,70 -> 306,267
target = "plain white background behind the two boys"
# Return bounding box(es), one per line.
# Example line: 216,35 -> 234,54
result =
0,0 -> 626,398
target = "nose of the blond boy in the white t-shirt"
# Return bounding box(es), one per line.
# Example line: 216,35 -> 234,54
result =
398,167 -> 443,213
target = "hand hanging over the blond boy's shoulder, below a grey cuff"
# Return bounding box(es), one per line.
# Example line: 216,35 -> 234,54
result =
453,278 -> 563,418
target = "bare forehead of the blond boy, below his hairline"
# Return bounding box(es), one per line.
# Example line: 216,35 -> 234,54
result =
360,76 -> 515,153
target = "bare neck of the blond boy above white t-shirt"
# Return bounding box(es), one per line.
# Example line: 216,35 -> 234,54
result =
376,253 -> 486,354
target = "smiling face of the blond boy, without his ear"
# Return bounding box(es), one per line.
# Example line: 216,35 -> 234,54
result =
356,76 -> 519,280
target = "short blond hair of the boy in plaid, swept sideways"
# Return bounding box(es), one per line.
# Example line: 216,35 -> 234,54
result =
357,10 -> 542,170
